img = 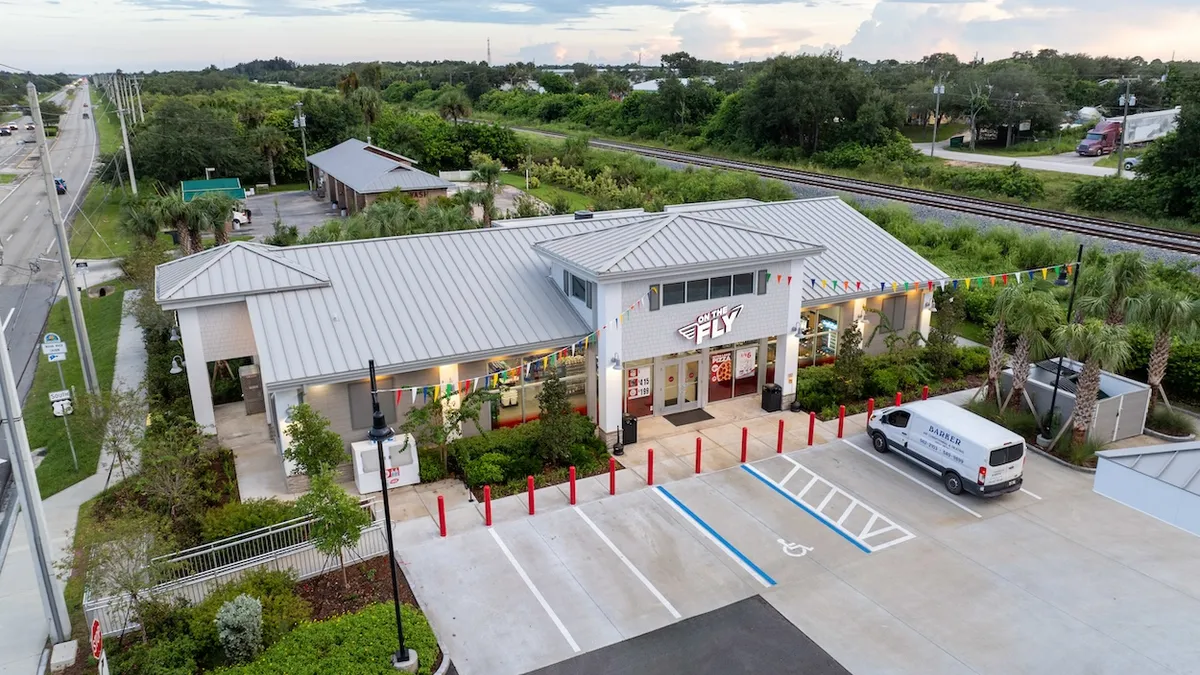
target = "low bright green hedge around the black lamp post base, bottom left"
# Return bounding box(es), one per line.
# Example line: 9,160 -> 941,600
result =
216,603 -> 438,675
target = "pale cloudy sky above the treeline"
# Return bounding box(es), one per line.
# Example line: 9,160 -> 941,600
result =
0,0 -> 1200,72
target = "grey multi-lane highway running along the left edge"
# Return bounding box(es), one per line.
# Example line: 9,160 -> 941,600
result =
0,85 -> 98,410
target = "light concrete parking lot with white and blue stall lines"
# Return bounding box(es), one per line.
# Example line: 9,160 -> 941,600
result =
396,435 -> 1200,675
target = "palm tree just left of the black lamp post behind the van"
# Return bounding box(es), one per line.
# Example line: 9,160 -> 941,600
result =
996,283 -> 1062,410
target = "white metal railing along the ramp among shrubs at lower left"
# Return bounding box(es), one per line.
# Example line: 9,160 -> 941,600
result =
83,506 -> 388,637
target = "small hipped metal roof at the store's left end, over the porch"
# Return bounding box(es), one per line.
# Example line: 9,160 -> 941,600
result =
155,241 -> 329,302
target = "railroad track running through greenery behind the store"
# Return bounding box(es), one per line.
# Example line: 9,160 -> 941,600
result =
514,127 -> 1200,256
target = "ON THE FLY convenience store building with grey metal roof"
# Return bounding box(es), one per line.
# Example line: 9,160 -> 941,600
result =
156,198 -> 944,478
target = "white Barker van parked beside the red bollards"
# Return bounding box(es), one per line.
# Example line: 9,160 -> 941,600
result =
866,400 -> 1025,497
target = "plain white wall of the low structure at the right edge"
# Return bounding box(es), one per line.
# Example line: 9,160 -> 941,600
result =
1093,456 -> 1200,537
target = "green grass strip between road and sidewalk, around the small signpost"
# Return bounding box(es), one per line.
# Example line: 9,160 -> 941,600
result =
25,282 -> 125,498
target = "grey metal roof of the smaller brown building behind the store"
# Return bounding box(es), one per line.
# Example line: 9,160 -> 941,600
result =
308,138 -> 451,195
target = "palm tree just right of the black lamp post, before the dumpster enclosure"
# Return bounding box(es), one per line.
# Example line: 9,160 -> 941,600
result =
1051,318 -> 1129,444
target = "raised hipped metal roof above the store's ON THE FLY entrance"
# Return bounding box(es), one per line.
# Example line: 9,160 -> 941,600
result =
534,213 -> 822,279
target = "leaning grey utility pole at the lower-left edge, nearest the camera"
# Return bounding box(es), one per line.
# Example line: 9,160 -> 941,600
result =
0,291 -> 71,644
